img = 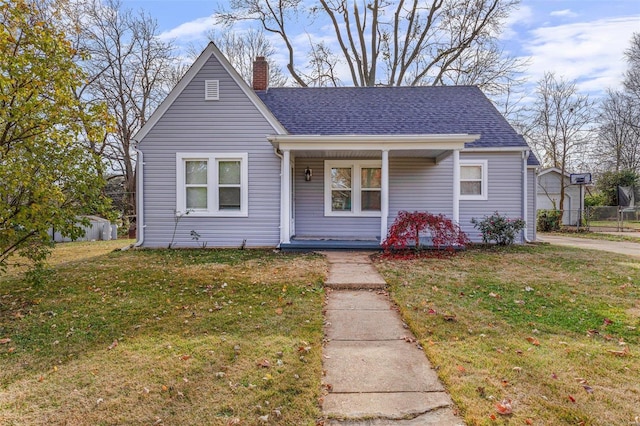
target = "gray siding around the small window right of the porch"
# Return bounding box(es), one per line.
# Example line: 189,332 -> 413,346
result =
460,152 -> 524,241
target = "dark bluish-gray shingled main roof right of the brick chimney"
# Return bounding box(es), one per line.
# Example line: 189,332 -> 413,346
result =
257,86 -> 527,155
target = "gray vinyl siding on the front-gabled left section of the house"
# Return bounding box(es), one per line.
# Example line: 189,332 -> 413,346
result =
140,56 -> 280,247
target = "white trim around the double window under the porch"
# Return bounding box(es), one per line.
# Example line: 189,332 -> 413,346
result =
324,160 -> 382,217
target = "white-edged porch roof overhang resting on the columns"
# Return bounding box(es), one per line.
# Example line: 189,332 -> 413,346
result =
267,134 -> 480,159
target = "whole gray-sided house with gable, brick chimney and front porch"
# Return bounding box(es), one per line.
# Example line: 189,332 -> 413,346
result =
135,44 -> 538,249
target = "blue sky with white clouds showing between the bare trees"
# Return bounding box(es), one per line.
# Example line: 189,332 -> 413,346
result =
123,0 -> 640,96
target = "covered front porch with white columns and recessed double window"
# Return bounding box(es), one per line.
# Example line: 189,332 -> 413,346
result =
269,134 -> 479,246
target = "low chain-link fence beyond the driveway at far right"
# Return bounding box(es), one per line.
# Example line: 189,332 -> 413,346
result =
537,206 -> 640,232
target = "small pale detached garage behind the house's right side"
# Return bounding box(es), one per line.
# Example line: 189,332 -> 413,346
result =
537,167 -> 584,226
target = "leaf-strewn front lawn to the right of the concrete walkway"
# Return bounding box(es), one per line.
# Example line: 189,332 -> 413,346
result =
377,246 -> 640,425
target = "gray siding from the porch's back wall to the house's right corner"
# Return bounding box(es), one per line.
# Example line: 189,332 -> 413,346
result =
294,152 -> 535,241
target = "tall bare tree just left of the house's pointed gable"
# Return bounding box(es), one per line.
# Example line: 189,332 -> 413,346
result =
67,0 -> 178,221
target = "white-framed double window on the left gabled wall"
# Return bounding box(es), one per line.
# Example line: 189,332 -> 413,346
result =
176,153 -> 248,216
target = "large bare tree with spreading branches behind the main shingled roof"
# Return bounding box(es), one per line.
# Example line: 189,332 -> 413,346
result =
220,0 -> 518,90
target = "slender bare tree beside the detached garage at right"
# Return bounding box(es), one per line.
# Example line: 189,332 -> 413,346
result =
525,72 -> 593,210
